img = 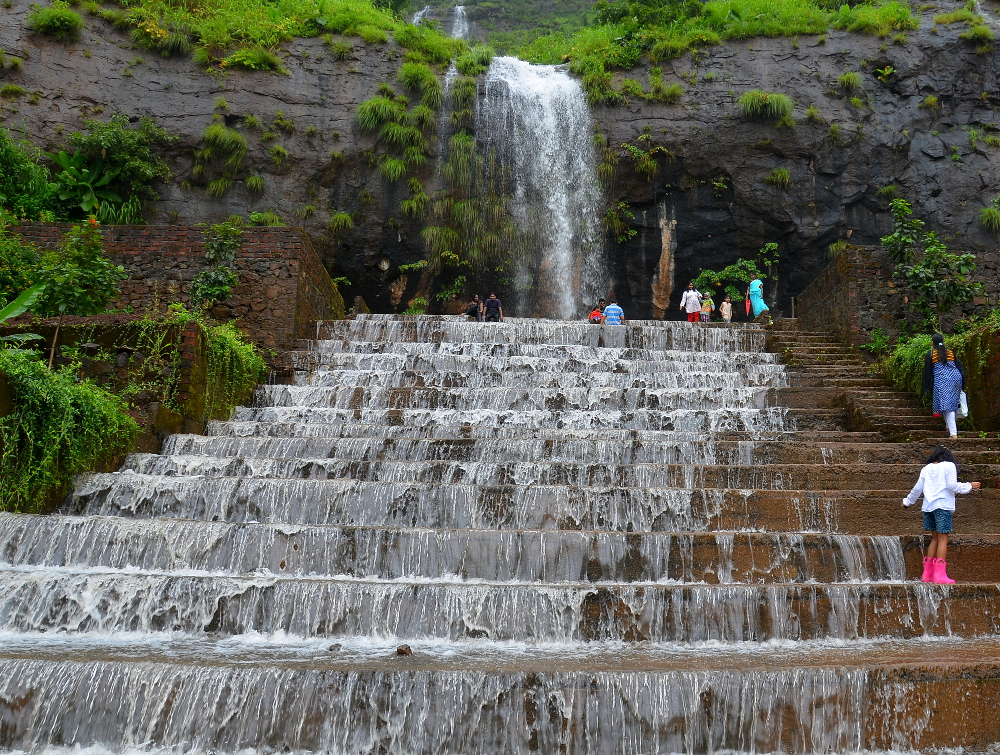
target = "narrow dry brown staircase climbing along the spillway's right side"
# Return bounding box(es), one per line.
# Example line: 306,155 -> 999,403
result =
768,318 -> 946,440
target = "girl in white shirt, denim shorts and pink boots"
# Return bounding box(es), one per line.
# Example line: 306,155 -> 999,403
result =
903,444 -> 982,585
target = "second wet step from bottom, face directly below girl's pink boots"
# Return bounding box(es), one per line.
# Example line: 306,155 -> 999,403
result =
0,567 -> 1000,643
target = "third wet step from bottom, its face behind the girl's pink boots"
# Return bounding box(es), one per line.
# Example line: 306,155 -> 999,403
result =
0,515 -> 936,584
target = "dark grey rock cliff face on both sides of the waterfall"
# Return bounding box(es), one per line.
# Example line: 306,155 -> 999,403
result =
0,0 -> 1000,316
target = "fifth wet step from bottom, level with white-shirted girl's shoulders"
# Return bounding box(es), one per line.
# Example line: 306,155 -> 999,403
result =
121,454 -> 1000,490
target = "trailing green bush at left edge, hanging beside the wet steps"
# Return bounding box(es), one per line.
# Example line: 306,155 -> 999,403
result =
0,349 -> 139,511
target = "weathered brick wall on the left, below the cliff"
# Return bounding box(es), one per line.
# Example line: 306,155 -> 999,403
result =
12,223 -> 344,348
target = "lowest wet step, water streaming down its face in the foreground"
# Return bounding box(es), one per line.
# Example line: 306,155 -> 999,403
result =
0,648 -> 1000,755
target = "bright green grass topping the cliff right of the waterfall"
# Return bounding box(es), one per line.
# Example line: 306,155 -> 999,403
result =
518,0 -> 918,104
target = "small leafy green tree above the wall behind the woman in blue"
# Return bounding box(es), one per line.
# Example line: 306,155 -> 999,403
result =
881,199 -> 983,330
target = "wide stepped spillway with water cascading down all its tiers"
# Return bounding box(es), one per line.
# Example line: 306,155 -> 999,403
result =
0,315 -> 1000,755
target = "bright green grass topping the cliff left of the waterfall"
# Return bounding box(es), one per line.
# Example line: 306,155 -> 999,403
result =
116,0 -> 464,70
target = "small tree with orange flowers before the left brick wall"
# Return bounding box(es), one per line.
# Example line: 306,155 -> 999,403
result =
34,218 -> 128,369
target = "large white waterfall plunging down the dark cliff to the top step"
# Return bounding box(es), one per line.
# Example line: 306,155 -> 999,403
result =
476,57 -> 603,318
